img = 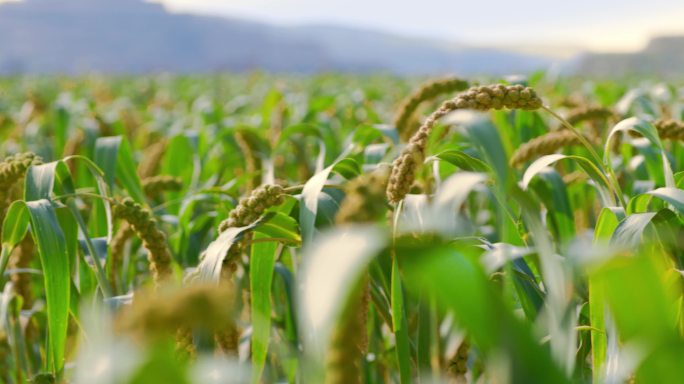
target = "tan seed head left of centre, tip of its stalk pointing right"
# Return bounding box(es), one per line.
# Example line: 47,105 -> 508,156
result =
219,185 -> 285,232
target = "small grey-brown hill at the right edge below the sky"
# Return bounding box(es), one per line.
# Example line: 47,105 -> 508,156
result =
576,36 -> 684,76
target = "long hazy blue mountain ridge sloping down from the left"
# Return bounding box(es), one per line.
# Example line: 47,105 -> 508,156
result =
0,0 -> 552,74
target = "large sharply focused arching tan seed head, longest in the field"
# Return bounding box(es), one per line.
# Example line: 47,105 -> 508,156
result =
387,84 -> 542,203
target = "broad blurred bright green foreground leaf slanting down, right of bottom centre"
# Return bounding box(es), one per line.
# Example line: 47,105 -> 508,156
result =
397,244 -> 568,383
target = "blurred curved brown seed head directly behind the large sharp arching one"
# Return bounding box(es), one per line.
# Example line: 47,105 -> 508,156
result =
394,78 -> 468,138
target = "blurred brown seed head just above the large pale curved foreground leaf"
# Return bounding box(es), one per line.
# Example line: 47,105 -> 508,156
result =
335,167 -> 389,224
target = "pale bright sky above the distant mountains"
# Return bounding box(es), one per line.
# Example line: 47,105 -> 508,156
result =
152,0 -> 684,52
